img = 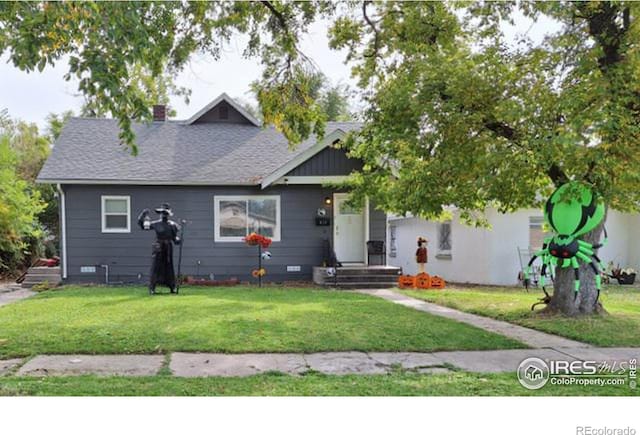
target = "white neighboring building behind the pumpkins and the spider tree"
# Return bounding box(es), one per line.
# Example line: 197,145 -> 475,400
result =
387,209 -> 640,285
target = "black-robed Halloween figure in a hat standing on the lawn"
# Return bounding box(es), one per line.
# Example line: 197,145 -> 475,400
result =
138,204 -> 184,295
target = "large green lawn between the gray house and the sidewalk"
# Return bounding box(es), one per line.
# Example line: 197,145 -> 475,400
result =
0,287 -> 524,358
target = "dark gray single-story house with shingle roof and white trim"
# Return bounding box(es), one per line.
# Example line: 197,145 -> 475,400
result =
38,94 -> 386,283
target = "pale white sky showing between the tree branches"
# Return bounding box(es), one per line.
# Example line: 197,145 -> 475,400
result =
0,8 -> 557,128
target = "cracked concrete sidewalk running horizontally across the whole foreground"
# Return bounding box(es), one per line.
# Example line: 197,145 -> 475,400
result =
0,347 -> 640,377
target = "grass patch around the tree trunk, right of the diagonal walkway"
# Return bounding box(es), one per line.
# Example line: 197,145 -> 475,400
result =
402,286 -> 640,347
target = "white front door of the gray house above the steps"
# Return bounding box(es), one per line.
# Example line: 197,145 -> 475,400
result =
333,193 -> 368,263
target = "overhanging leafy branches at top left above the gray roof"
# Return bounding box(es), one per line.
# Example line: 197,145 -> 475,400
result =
0,1 -> 336,154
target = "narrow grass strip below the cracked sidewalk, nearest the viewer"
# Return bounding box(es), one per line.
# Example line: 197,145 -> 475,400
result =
0,372 -> 638,396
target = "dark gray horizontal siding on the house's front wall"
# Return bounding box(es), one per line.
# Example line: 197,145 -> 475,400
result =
62,185 -> 386,284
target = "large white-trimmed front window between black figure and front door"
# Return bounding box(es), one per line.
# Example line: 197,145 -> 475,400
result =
213,195 -> 280,242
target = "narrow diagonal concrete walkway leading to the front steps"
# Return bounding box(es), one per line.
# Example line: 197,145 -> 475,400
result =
357,289 -> 592,349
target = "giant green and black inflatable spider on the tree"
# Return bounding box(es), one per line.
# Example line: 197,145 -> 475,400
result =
524,182 -> 607,302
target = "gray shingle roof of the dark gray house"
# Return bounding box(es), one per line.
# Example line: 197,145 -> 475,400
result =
38,118 -> 360,185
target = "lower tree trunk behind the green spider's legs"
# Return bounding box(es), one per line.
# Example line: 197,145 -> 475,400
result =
544,221 -> 606,316
